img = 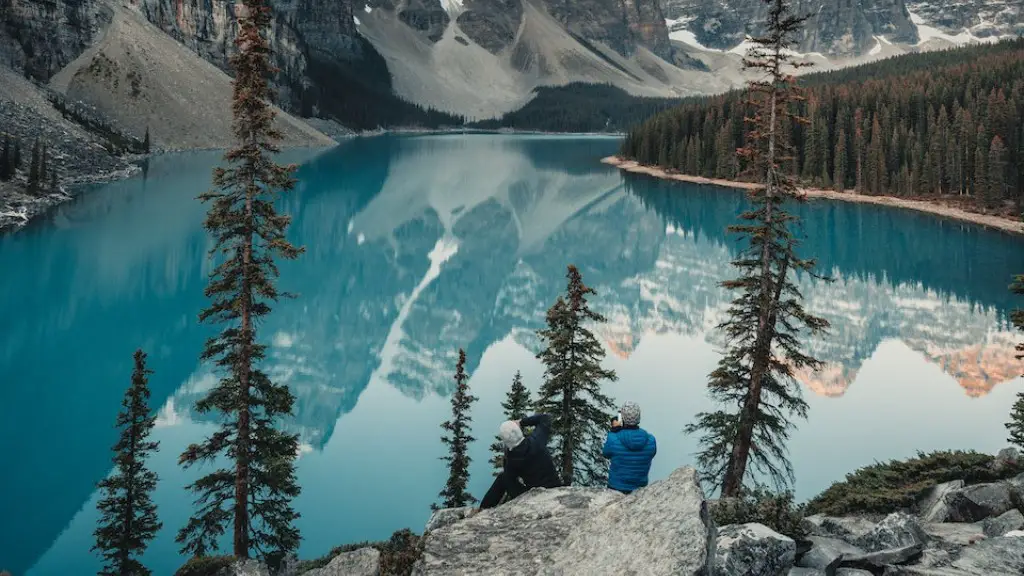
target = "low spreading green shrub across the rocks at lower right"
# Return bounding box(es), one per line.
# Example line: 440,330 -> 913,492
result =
807,450 -> 1024,516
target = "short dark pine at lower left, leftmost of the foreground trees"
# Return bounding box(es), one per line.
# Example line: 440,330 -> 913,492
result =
92,349 -> 163,576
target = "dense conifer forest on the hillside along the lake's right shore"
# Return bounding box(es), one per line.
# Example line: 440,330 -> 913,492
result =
622,39 -> 1024,210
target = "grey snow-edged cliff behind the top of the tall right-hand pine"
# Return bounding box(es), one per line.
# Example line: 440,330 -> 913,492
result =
665,0 -> 918,56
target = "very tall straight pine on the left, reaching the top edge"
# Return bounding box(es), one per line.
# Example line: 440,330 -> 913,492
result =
177,0 -> 302,565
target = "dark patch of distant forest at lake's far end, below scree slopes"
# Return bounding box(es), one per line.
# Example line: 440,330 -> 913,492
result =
473,82 -> 679,132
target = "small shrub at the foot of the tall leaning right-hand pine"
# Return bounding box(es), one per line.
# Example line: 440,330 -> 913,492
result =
711,489 -> 807,539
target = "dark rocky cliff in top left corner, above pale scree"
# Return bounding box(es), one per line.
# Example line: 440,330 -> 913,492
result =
0,0 -> 110,81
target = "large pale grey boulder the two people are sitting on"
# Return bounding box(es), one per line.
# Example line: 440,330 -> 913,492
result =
413,466 -> 715,576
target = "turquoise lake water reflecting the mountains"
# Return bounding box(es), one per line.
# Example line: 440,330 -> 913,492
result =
0,135 -> 1024,576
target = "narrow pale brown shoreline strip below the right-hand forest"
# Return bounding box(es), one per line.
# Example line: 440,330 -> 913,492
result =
601,156 -> 1024,236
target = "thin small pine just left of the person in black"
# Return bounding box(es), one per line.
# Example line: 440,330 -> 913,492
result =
430,348 -> 477,510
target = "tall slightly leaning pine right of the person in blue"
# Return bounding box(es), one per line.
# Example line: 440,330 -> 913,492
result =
686,0 -> 827,497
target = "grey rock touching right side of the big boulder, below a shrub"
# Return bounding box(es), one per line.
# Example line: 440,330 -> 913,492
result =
709,523 -> 797,576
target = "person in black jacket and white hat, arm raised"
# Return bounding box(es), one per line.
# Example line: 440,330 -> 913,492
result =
480,414 -> 562,510
